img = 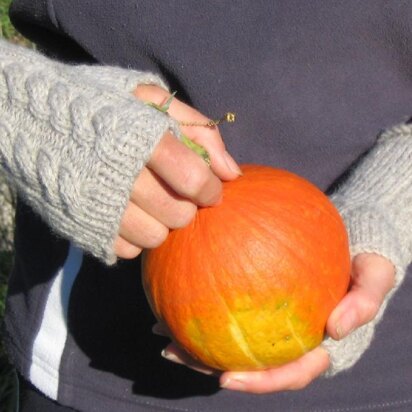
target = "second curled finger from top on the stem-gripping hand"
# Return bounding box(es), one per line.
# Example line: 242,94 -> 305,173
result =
130,168 -> 197,229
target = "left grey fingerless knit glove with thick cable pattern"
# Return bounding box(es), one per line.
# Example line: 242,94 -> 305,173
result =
0,41 -> 178,264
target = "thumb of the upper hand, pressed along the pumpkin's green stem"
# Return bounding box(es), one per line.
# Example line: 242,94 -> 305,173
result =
134,85 -> 241,180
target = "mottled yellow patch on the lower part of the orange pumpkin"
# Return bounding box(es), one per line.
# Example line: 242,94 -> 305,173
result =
186,297 -> 321,370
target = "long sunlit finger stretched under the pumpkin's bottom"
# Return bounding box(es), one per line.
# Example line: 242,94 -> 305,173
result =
220,347 -> 329,394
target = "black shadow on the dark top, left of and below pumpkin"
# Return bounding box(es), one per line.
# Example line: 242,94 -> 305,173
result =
68,254 -> 219,398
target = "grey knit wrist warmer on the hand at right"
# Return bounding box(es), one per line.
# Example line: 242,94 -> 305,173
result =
323,125 -> 412,376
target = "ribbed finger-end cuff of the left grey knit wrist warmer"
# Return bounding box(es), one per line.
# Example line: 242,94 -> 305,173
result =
72,105 -> 175,264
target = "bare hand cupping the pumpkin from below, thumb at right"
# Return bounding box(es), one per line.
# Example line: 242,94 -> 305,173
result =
159,253 -> 395,393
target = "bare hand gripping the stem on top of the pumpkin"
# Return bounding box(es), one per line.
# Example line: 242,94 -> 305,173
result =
114,85 -> 240,259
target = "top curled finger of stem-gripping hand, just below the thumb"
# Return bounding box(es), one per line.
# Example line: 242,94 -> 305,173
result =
147,133 -> 222,206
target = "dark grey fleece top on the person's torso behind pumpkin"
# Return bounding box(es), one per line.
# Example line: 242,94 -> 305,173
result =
8,0 -> 412,412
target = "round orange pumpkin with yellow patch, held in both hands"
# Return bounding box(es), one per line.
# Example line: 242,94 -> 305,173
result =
143,165 -> 350,370
